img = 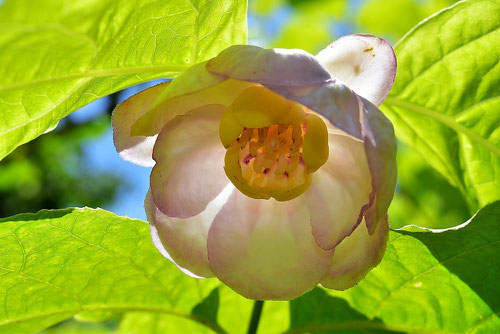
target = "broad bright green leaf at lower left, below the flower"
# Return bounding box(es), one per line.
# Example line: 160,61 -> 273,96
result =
0,208 -> 223,333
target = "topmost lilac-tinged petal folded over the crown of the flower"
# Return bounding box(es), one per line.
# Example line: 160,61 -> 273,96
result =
207,45 -> 331,86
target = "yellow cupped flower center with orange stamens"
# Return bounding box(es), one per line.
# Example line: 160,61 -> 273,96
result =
219,87 -> 328,201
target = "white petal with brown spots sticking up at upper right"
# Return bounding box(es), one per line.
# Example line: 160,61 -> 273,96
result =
316,34 -> 397,106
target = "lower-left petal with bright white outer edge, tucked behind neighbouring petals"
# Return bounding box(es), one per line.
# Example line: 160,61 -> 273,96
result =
144,185 -> 234,278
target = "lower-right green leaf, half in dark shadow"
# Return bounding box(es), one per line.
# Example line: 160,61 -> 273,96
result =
326,201 -> 500,333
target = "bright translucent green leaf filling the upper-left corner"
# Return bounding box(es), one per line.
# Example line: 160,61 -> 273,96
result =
0,0 -> 246,159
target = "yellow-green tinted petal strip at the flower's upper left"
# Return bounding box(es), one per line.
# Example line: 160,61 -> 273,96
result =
132,62 -> 255,136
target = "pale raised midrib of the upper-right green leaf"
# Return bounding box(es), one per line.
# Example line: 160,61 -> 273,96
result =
384,97 -> 500,157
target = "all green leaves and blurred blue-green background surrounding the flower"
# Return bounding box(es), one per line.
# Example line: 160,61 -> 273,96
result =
0,0 -> 500,334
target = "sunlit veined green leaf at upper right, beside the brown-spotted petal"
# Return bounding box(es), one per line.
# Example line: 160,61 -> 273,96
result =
382,0 -> 500,209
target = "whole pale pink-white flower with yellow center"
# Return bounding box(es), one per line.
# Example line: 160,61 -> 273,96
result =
113,34 -> 396,300
